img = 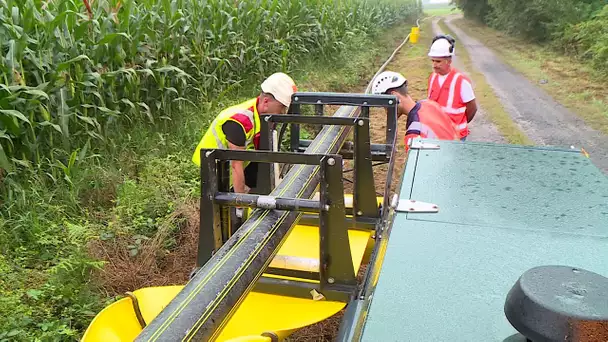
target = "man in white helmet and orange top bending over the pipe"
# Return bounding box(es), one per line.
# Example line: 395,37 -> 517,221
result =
372,71 -> 459,150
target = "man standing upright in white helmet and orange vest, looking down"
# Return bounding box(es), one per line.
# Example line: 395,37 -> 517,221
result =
428,35 -> 477,141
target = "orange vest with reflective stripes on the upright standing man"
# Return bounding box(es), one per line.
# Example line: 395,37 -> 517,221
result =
428,68 -> 471,138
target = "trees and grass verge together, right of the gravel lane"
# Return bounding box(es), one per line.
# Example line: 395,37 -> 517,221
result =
446,0 -> 608,134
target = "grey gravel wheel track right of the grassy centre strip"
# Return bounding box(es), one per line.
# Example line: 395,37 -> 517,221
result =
434,15 -> 608,174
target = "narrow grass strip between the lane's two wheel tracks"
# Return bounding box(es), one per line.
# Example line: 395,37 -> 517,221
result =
438,19 -> 534,145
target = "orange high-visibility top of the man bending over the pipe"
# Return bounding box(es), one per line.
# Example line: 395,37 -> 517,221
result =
404,100 -> 460,151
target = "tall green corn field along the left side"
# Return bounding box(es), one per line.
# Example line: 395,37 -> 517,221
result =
0,0 -> 419,175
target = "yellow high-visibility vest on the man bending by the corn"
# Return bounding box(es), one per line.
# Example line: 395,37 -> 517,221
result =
192,97 -> 260,167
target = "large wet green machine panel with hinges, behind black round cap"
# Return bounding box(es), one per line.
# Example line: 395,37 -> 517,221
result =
362,140 -> 608,342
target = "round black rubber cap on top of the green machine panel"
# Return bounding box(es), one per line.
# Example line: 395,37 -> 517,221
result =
504,266 -> 608,342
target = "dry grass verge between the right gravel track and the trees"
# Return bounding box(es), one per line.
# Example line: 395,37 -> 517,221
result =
452,19 -> 608,134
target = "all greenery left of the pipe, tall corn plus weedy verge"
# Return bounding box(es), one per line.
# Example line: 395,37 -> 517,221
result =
0,0 -> 420,341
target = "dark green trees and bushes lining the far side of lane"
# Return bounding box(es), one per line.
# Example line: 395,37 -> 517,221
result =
452,0 -> 608,76
